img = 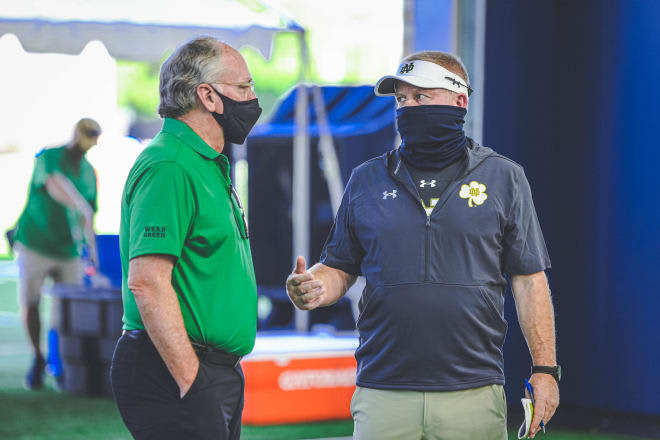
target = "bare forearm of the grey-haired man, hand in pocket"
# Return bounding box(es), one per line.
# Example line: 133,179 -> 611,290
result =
129,260 -> 199,393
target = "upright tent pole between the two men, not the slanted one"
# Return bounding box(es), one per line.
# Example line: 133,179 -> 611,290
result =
291,29 -> 311,331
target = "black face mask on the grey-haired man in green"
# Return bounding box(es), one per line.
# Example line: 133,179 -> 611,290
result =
211,87 -> 261,144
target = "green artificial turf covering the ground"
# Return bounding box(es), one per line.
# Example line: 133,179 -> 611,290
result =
0,272 -> 652,440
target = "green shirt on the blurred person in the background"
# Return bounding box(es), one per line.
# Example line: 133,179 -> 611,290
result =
16,147 -> 96,259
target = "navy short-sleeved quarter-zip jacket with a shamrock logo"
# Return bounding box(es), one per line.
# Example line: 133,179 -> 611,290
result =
321,140 -> 550,391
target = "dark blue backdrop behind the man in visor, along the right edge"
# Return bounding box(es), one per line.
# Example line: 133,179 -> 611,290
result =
484,0 -> 660,415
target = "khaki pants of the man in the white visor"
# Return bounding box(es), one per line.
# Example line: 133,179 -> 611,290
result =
351,385 -> 507,440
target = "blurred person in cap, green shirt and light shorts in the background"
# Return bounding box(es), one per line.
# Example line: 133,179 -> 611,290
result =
14,118 -> 101,389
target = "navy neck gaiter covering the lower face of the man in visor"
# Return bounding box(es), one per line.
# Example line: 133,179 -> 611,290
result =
396,105 -> 468,170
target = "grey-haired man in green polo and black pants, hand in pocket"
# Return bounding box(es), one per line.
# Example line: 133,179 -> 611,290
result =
111,37 -> 261,439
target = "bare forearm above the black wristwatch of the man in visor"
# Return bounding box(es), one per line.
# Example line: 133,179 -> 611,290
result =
511,272 -> 557,365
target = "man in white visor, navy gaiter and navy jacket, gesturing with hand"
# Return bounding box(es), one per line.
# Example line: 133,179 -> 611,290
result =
286,52 -> 560,440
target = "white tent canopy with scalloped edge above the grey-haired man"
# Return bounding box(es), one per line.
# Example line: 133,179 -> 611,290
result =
0,0 -> 303,61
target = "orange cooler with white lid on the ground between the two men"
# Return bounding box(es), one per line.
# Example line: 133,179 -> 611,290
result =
241,333 -> 358,425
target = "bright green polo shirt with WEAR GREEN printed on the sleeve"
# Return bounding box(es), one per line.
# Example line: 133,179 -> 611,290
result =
119,118 -> 257,355
